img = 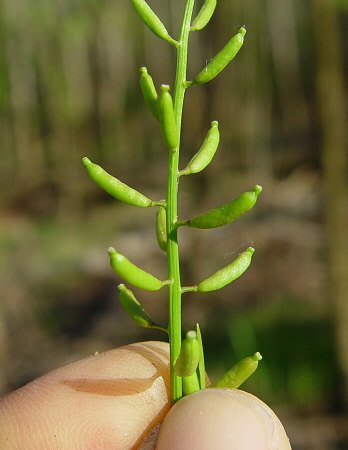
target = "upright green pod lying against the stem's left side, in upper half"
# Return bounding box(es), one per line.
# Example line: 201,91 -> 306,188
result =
159,84 -> 178,150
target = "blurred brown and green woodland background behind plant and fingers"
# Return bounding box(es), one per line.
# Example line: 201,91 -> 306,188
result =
0,0 -> 348,450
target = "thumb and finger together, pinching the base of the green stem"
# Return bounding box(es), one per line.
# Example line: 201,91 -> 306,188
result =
0,342 -> 290,450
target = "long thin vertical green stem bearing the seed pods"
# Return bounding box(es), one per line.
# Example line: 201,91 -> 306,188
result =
167,0 -> 195,403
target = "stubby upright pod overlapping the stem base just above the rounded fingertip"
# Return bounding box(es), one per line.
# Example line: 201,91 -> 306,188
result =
174,331 -> 199,377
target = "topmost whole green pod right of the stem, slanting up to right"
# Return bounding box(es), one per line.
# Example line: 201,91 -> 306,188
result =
191,27 -> 246,84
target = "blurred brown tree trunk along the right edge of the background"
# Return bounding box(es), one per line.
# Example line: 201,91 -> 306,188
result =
312,0 -> 348,408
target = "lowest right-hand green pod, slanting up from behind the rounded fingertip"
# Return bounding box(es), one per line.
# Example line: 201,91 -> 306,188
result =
213,352 -> 262,389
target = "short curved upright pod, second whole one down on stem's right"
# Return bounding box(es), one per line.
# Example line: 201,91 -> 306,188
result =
179,120 -> 220,175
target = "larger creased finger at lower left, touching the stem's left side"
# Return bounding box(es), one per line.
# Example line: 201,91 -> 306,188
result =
0,342 -> 169,450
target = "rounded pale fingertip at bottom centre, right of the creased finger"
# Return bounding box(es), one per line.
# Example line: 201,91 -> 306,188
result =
156,389 -> 291,450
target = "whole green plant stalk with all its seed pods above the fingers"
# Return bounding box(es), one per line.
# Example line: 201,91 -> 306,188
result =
83,0 -> 261,402
